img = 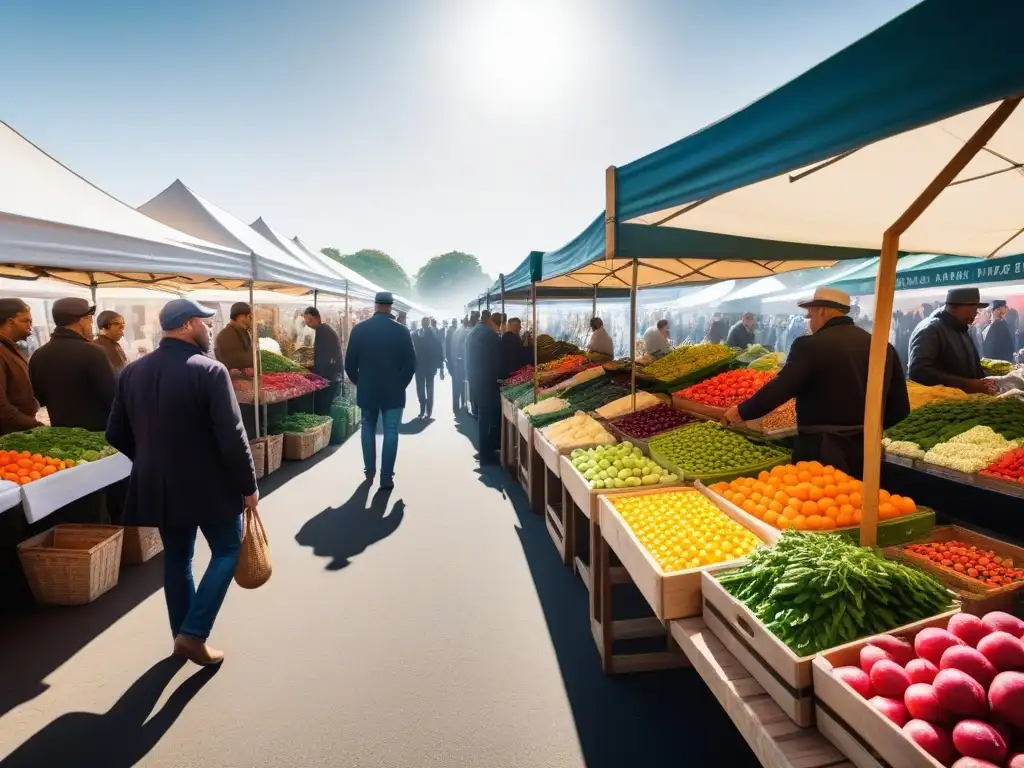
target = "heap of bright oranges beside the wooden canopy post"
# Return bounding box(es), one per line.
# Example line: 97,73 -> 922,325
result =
711,462 -> 918,530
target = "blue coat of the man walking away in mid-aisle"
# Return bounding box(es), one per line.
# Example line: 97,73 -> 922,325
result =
345,312 -> 416,411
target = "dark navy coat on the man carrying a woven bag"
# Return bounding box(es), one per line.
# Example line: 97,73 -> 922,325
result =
104,339 -> 256,527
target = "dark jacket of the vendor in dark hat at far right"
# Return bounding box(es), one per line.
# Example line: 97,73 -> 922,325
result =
908,309 -> 985,389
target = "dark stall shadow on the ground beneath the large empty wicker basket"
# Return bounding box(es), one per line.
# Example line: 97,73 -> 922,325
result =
0,555 -> 164,720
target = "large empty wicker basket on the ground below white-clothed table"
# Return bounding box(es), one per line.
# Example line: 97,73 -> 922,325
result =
17,524 -> 124,605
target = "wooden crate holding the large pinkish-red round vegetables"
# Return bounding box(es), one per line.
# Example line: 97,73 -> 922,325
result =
811,610 -> 957,768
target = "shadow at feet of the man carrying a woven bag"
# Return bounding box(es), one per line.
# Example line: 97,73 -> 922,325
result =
0,656 -> 219,768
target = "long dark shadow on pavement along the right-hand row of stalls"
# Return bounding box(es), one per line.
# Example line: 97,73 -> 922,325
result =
456,417 -> 759,768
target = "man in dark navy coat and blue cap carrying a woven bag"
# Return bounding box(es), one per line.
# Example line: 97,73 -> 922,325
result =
106,299 -> 259,665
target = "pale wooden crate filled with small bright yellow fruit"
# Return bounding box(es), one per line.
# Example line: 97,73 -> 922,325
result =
600,486 -> 769,621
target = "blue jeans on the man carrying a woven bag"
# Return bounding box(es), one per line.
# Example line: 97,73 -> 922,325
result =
160,514 -> 242,640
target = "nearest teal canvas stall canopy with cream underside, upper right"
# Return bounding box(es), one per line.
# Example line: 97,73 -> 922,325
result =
616,0 -> 1024,257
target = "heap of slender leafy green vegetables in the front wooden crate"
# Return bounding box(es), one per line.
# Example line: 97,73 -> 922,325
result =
719,530 -> 952,656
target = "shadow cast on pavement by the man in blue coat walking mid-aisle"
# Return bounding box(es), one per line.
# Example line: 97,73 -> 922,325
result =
295,480 -> 406,570
